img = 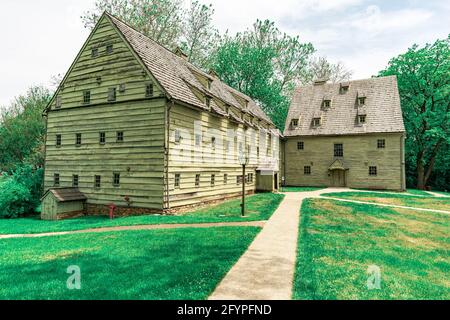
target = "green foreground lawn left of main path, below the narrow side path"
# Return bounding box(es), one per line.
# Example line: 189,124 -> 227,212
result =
0,227 -> 260,300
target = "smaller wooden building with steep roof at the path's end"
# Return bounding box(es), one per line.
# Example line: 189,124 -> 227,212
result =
283,76 -> 405,190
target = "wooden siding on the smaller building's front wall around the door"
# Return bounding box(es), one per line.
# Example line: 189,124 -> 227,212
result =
284,134 -> 404,190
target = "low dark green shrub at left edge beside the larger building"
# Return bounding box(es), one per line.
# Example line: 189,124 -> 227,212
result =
0,165 -> 43,218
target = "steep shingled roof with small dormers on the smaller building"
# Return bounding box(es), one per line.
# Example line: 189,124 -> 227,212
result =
284,76 -> 405,136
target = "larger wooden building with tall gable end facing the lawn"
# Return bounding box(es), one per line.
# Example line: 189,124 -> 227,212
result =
44,13 -> 280,218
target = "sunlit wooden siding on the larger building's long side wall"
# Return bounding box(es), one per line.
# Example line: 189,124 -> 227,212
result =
168,104 -> 278,207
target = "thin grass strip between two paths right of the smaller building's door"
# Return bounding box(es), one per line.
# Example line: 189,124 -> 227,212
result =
322,192 -> 450,211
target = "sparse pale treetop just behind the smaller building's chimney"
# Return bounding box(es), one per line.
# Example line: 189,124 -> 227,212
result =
307,57 -> 353,83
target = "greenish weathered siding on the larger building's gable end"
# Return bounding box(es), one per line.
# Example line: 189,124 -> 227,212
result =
45,18 -> 165,209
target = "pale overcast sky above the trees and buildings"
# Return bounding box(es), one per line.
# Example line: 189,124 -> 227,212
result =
0,0 -> 450,105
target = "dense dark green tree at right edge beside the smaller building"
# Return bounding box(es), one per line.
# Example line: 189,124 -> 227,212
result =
380,36 -> 450,189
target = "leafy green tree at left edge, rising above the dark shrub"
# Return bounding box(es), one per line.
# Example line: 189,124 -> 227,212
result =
0,87 -> 51,172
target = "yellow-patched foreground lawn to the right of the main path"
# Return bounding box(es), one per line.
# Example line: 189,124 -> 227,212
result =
293,199 -> 450,300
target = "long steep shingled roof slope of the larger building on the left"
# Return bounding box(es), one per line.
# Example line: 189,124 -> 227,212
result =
105,13 -> 273,125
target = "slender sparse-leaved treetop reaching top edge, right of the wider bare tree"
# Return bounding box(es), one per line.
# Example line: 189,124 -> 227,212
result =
181,1 -> 219,67
